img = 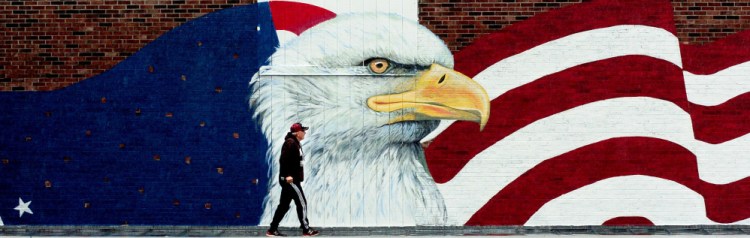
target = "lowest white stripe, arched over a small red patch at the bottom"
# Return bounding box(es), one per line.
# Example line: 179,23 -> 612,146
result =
524,175 -> 750,226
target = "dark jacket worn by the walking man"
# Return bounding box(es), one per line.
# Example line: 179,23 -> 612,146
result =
279,132 -> 305,182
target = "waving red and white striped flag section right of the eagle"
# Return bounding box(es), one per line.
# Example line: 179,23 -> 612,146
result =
425,0 -> 750,225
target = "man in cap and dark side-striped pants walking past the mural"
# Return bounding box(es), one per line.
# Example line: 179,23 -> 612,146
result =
266,123 -> 320,236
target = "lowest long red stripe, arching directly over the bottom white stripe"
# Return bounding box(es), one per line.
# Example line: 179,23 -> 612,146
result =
466,137 -> 750,225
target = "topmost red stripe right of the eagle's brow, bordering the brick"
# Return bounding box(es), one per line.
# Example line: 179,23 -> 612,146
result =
454,0 -> 676,77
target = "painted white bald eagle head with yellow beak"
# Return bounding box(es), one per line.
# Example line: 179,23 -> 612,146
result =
250,13 -> 489,226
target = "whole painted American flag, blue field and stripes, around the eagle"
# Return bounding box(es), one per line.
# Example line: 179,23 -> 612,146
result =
0,0 -> 750,226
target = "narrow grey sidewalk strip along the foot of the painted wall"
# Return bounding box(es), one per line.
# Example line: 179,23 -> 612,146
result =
0,225 -> 750,237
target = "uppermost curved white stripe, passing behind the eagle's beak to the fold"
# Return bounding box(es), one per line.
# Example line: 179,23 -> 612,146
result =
423,25 -> 682,141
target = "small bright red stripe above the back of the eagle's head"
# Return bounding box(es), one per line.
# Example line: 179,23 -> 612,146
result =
268,1 -> 336,35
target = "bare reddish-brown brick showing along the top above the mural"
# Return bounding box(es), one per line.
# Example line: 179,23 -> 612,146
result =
0,0 -> 750,91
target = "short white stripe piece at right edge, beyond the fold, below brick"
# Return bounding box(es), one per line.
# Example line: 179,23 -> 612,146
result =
683,62 -> 750,106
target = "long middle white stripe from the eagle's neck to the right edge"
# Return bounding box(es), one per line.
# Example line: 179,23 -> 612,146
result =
438,97 -> 750,224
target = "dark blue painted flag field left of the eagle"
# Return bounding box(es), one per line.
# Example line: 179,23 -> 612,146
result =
0,3 -> 278,225
